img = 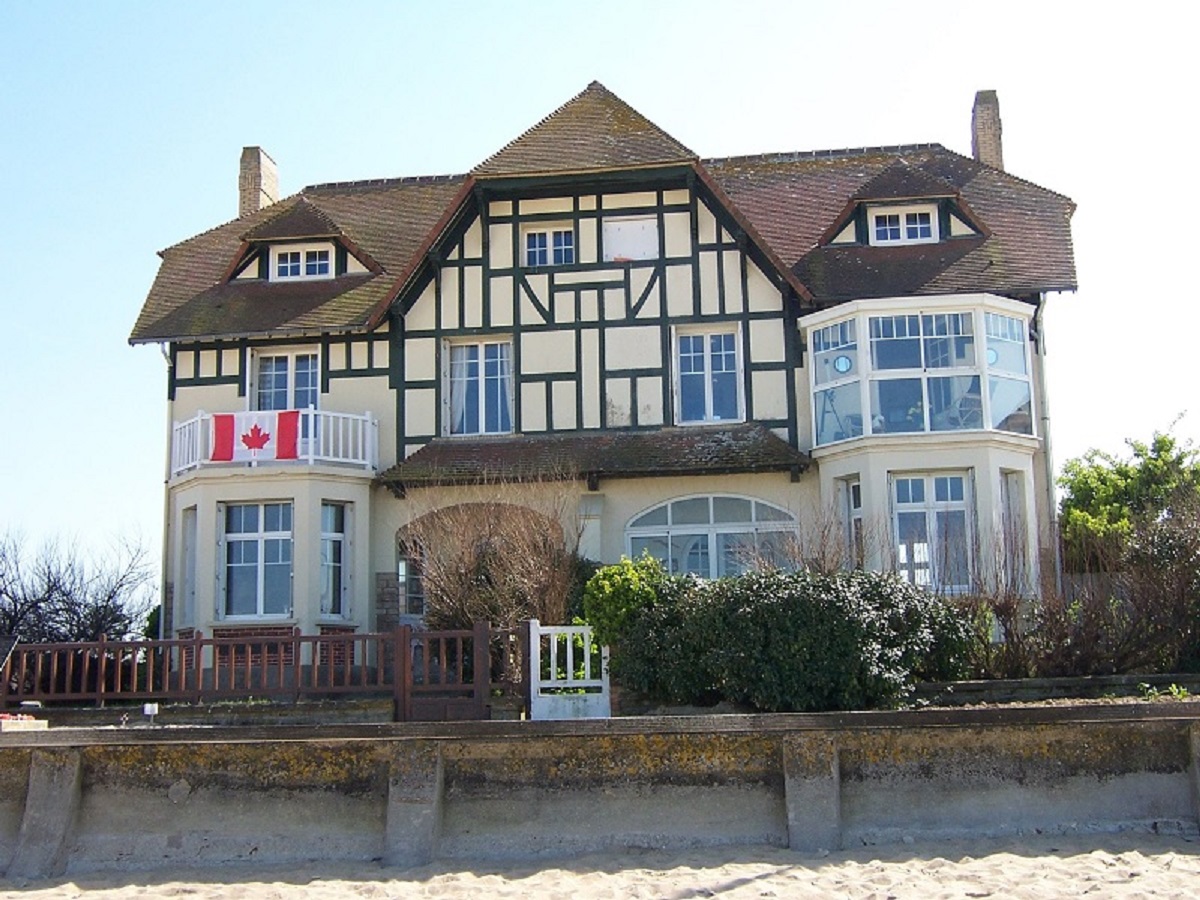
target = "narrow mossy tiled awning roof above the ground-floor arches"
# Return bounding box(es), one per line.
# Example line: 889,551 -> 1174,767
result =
379,422 -> 809,488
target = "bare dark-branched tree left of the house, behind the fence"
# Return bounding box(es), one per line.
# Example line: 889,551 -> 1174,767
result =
0,533 -> 154,643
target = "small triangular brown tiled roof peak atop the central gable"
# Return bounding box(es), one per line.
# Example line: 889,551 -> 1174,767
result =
472,82 -> 696,178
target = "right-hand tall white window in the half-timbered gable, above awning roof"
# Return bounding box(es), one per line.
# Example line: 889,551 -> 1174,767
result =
676,331 -> 743,422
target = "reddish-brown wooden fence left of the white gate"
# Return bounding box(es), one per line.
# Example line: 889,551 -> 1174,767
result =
0,623 -> 506,721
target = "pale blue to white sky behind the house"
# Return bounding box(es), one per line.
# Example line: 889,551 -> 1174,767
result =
0,0 -> 1200,552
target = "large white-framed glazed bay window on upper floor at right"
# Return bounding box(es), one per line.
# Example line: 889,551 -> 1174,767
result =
810,310 -> 1033,446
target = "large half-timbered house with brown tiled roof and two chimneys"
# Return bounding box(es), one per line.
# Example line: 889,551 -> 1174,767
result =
131,83 -> 1075,636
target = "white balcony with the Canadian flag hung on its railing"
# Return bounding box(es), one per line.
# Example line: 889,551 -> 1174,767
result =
170,408 -> 379,478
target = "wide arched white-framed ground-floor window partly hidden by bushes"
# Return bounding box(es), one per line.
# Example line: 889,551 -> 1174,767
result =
625,494 -> 799,578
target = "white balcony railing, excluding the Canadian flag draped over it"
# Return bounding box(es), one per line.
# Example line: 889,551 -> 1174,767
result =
170,408 -> 379,476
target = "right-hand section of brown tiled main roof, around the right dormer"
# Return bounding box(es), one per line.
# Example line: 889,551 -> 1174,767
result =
703,144 -> 1075,305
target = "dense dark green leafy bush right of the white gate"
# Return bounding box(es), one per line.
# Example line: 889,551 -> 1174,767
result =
586,559 -> 971,712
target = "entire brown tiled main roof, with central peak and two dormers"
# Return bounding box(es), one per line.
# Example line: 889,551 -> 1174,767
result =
130,82 -> 1075,343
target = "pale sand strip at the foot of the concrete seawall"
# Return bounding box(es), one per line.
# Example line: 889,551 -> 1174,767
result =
0,833 -> 1200,900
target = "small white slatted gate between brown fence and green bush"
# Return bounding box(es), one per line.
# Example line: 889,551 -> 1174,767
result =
529,619 -> 612,719
